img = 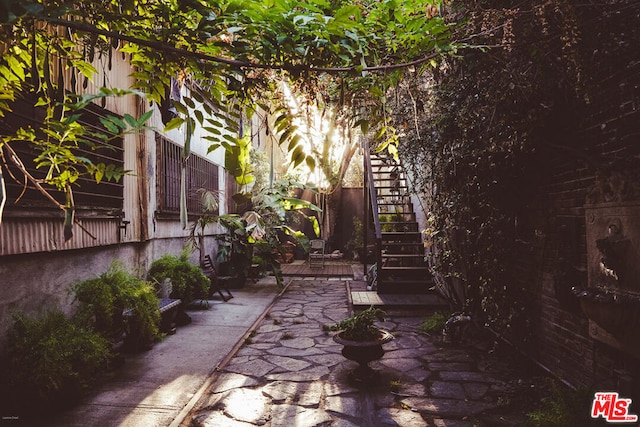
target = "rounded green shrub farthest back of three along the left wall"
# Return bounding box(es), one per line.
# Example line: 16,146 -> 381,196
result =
148,252 -> 211,304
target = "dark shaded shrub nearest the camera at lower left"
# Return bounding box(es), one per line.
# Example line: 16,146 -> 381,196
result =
7,310 -> 111,408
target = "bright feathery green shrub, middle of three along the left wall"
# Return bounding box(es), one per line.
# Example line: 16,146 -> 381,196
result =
72,262 -> 160,347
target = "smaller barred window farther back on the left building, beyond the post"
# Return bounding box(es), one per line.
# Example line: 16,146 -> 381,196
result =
156,135 -> 219,215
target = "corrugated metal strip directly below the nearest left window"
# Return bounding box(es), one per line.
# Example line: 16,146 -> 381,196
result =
0,218 -> 124,256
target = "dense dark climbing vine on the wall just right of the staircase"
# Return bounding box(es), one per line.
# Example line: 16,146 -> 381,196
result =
389,0 -> 638,340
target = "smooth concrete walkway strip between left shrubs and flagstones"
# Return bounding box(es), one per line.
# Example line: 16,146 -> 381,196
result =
46,278 -> 278,427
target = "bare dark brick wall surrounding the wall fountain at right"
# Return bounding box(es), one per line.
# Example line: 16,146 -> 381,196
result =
527,20 -> 640,400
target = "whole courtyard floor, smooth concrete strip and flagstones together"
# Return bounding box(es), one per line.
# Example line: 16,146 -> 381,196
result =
48,270 -> 543,427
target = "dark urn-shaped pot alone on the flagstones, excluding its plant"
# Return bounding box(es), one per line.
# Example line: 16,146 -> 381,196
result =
333,330 -> 394,383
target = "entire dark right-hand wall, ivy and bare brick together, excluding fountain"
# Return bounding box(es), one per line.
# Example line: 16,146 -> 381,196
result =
390,0 -> 640,392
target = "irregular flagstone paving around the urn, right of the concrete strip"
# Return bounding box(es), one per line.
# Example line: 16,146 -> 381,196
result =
182,279 -> 534,427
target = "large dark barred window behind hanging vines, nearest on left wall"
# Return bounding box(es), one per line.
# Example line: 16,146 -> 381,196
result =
0,97 -> 124,217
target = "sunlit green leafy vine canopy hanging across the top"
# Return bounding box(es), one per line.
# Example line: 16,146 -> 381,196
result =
0,0 -> 463,227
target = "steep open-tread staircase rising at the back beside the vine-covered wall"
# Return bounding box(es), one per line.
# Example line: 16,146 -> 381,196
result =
365,150 -> 434,294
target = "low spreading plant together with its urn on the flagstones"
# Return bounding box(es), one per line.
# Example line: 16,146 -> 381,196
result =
325,306 -> 393,384
